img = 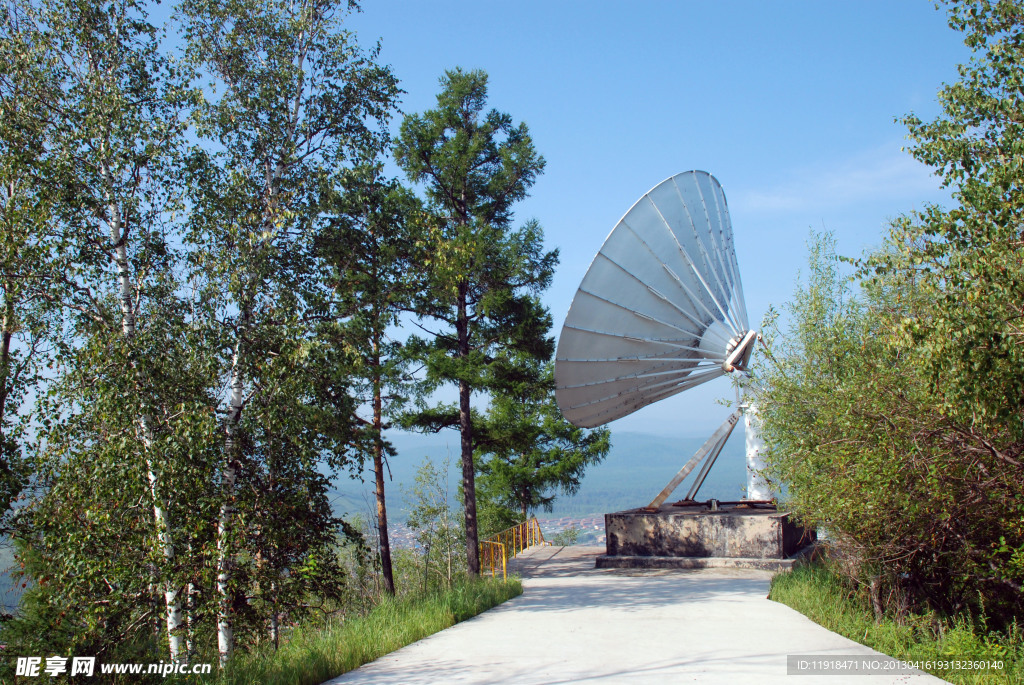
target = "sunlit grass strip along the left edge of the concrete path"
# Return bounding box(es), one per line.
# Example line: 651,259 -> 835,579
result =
193,579 -> 522,685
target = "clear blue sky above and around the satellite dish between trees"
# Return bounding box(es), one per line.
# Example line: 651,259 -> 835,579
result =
347,0 -> 969,435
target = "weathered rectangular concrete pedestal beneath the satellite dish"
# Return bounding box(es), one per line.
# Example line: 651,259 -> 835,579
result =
597,504 -> 815,569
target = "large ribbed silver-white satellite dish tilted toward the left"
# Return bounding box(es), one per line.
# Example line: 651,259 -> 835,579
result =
555,171 -> 757,428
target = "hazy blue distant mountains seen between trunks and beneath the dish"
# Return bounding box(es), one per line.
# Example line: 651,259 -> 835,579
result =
335,426 -> 746,521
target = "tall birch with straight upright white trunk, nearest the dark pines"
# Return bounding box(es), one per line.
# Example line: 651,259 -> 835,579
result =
181,0 -> 397,666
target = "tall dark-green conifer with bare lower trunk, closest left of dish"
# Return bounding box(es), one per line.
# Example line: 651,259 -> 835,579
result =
394,69 -> 558,573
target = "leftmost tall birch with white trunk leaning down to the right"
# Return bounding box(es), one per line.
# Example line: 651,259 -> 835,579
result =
0,0 -> 194,660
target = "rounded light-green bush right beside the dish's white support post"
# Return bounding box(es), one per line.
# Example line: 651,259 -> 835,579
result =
757,233 -> 1024,620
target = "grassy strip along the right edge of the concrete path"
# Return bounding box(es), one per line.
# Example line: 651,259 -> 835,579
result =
769,564 -> 1024,685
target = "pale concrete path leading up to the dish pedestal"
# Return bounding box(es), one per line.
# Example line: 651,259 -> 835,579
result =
329,547 -> 945,685
